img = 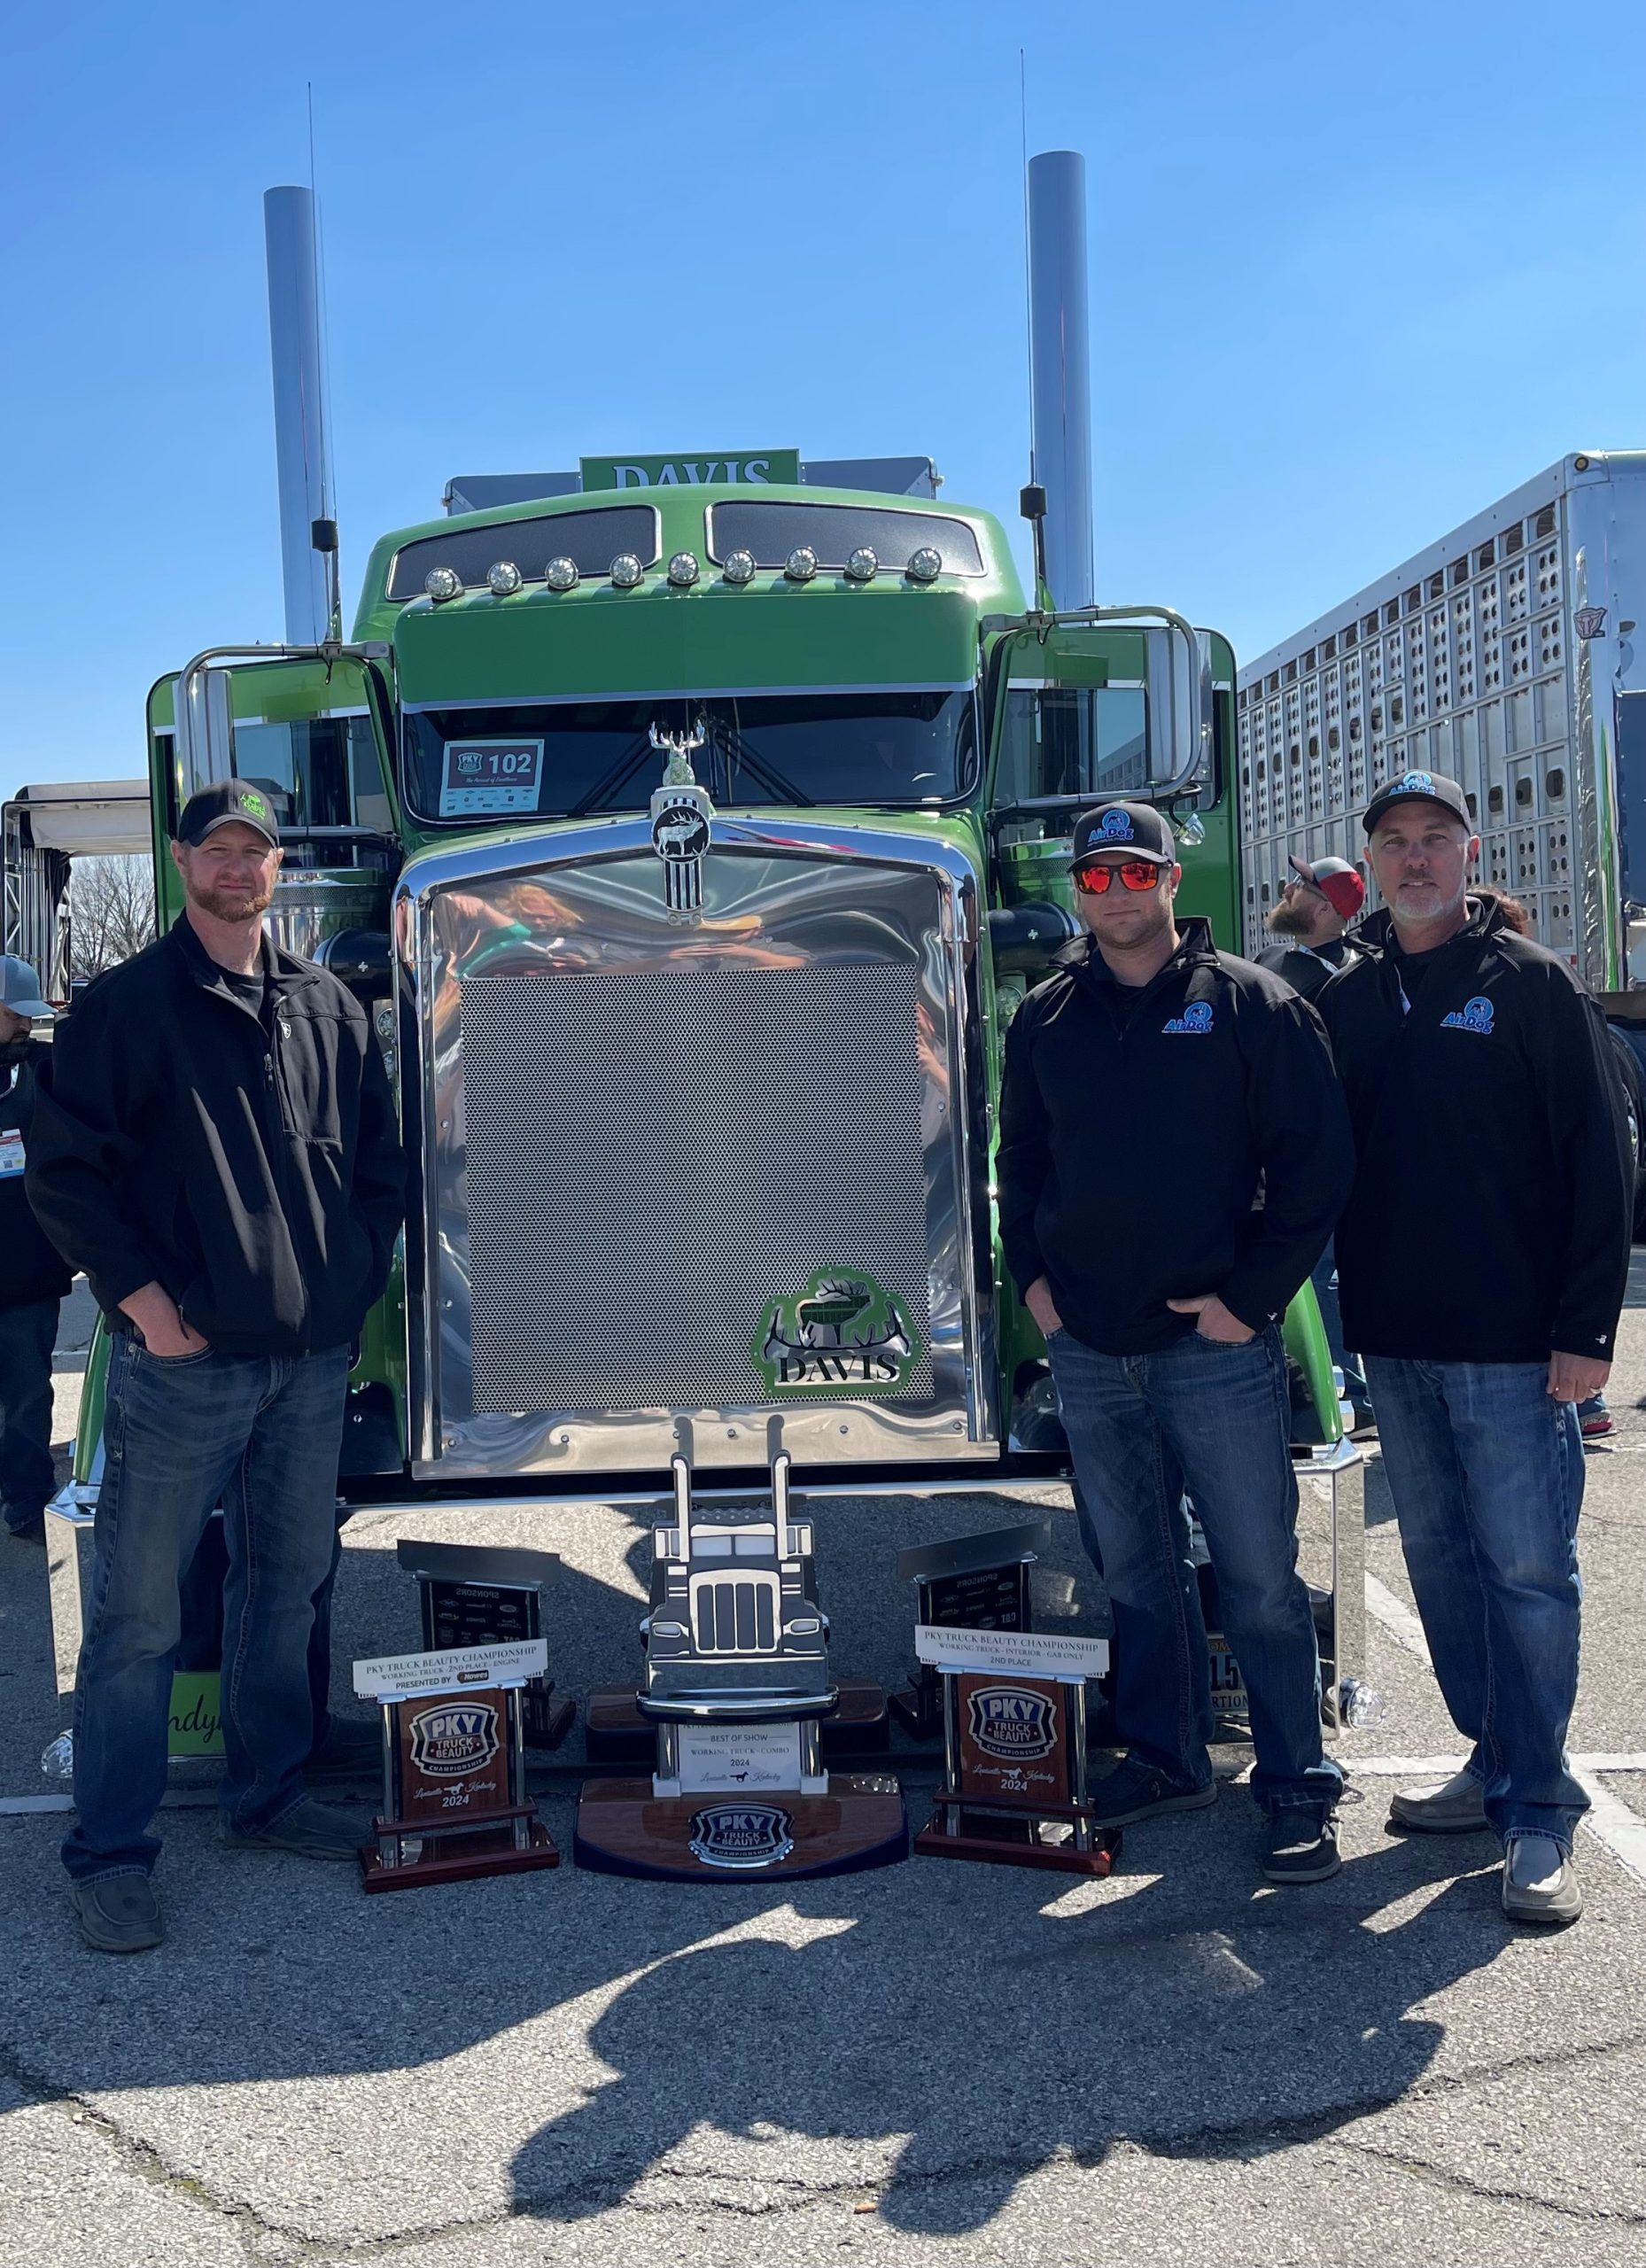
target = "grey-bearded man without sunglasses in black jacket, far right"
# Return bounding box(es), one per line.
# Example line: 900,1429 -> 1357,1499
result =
1322,771 -> 1633,1921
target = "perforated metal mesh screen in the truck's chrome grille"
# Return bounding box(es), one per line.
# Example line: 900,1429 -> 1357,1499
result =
462,967 -> 932,1415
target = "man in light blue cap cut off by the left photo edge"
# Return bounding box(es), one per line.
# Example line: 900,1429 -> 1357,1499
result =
0,952 -> 73,1544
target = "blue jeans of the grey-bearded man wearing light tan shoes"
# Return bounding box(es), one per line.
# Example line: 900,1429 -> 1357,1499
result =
1367,1354 -> 1589,1851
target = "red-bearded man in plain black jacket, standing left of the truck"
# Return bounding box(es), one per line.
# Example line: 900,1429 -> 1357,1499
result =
27,781 -> 401,1953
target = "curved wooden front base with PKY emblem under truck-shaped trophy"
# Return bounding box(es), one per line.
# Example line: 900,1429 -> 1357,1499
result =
571,1771 -> 909,1883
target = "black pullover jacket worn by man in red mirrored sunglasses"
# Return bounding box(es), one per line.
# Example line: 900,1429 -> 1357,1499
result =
998,920 -> 1354,1354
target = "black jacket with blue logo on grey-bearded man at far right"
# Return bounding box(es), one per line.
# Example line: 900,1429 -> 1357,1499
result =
1319,900 -> 1634,1363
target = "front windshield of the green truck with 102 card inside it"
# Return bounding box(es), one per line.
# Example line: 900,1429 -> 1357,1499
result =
404,687 -> 977,821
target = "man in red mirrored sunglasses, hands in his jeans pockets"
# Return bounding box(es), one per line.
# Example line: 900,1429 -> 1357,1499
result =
998,803 -> 1351,1883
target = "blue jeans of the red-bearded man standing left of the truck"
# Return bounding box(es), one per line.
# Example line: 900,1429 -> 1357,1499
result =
64,1333 -> 349,1883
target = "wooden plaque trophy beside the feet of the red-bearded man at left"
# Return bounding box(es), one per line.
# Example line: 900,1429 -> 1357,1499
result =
353,1637 -> 560,1891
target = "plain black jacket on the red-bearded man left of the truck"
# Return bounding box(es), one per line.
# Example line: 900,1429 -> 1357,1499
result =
27,920 -> 404,1354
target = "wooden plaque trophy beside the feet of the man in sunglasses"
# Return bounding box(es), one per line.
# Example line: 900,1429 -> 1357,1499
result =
913,1624 -> 1120,1876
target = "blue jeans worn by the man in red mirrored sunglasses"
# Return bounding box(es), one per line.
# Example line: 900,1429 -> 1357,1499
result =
1047,1327 -> 1342,1812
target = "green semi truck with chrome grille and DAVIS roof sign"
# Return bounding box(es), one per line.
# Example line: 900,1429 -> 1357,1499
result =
42,449 -> 1369,1714
